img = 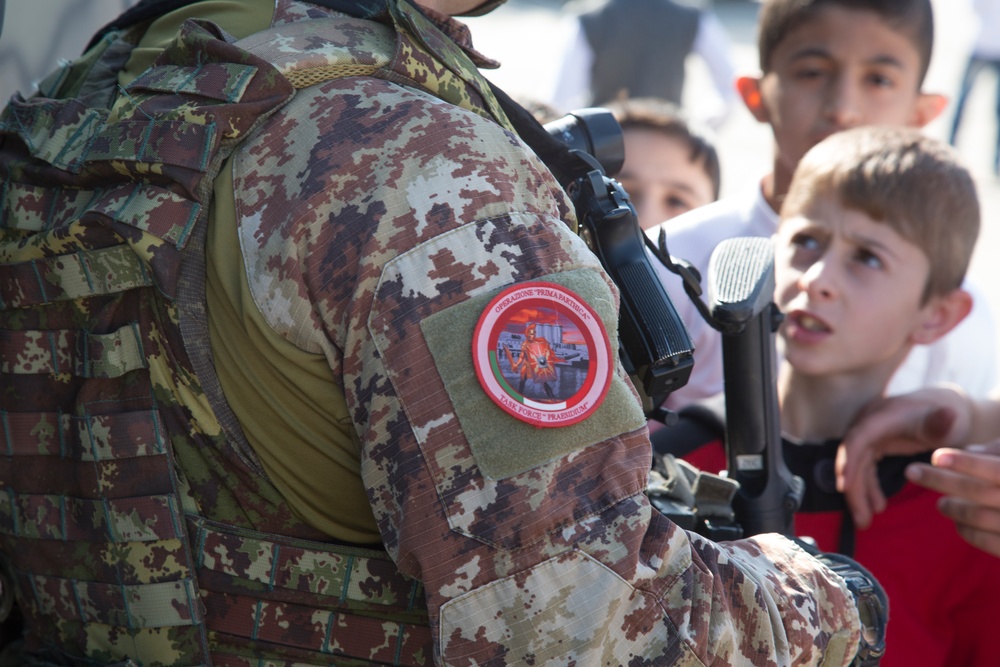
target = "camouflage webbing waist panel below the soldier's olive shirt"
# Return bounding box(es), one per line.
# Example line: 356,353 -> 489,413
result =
188,517 -> 433,665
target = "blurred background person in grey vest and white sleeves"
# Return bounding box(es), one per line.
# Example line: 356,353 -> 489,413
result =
552,0 -> 737,127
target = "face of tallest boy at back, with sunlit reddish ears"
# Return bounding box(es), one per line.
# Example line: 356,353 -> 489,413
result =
741,6 -> 943,185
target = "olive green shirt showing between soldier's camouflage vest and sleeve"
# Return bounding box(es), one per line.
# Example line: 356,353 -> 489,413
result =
119,0 -> 381,544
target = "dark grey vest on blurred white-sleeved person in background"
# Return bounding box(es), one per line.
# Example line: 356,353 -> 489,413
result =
580,0 -> 700,104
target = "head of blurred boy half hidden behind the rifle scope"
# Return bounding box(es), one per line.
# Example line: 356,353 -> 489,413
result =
607,97 -> 721,230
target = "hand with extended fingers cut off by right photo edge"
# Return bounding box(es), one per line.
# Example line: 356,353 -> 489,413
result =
906,440 -> 1000,556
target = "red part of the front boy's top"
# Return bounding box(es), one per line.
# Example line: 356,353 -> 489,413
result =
684,441 -> 1000,667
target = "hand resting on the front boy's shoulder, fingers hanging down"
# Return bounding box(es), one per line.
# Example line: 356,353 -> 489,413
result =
836,387 -> 972,528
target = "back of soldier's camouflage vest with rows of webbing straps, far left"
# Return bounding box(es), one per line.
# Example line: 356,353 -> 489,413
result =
0,18 -> 293,666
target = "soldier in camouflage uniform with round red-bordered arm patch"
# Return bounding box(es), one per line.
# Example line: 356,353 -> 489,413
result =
0,0 -> 860,666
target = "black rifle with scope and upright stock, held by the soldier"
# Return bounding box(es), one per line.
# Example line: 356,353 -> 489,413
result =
494,96 -> 888,667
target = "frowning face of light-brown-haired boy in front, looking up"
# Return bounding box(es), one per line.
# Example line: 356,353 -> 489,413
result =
775,196 -> 933,375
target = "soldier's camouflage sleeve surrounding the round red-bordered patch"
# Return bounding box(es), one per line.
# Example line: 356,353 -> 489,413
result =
229,78 -> 859,665
